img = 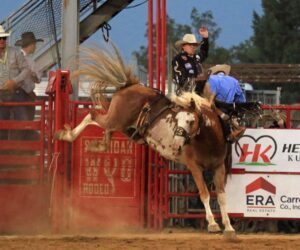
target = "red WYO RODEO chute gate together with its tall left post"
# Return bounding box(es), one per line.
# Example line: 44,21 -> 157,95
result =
48,71 -> 145,232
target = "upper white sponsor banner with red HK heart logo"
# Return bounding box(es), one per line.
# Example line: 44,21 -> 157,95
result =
232,129 -> 300,173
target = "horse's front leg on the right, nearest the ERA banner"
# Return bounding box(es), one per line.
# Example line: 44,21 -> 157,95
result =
214,164 -> 235,236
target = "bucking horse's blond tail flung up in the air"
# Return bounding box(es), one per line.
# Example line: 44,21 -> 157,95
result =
72,43 -> 139,106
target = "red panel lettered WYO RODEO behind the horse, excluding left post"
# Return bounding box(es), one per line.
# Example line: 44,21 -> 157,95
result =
69,102 -> 145,230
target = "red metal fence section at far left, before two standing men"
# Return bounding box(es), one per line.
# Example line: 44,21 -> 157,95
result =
0,101 -> 49,232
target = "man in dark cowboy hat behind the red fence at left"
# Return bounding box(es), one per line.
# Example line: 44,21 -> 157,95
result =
15,32 -> 44,120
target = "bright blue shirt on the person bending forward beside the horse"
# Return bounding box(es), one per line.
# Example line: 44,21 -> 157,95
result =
208,73 -> 246,103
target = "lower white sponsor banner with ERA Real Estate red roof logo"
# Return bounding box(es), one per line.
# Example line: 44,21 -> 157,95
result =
226,174 -> 300,218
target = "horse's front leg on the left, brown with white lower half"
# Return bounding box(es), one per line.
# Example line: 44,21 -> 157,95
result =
188,163 -> 221,232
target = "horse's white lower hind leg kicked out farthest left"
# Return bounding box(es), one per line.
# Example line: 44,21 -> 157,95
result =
54,113 -> 99,142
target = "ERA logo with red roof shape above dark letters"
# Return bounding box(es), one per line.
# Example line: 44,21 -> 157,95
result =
246,177 -> 276,208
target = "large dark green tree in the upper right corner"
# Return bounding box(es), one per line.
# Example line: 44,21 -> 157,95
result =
233,0 -> 300,63
